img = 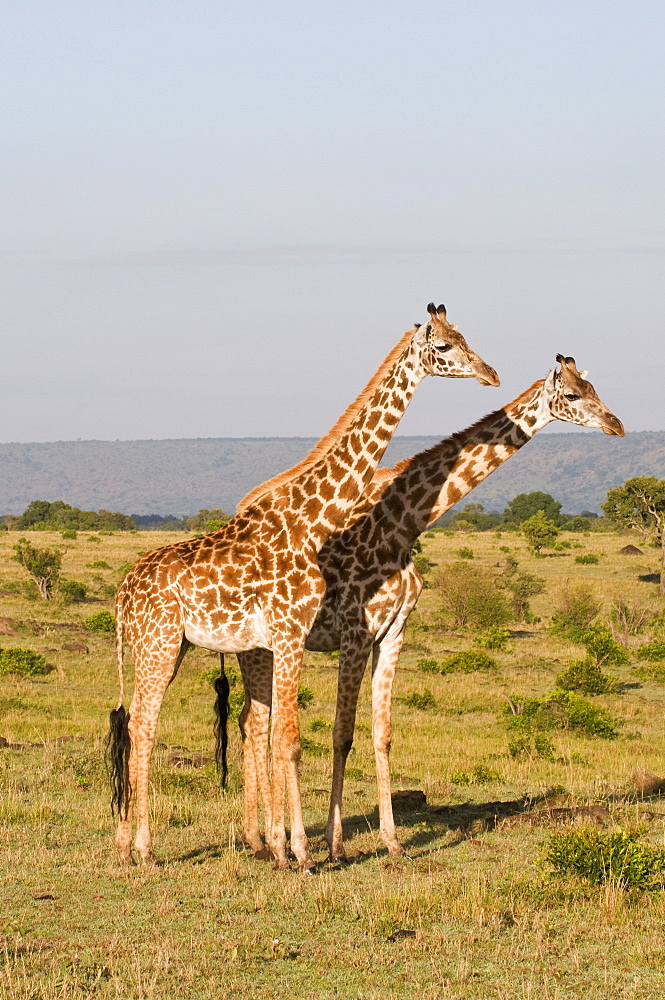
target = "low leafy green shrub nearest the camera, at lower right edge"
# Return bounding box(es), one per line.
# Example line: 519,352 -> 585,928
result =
544,827 -> 665,889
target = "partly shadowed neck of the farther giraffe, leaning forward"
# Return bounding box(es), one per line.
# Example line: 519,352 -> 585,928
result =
366,381 -> 554,546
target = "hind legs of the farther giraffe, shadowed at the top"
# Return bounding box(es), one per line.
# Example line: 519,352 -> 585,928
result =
238,649 -> 272,857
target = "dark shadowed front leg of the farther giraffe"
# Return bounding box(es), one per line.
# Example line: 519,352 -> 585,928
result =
325,629 -> 372,860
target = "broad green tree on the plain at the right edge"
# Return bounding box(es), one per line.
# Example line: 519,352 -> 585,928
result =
600,476 -> 665,594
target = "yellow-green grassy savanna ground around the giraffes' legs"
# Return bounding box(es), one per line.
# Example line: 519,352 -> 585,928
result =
0,533 -> 665,1000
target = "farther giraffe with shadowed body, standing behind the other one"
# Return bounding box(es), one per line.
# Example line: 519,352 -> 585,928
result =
232,354 -> 624,860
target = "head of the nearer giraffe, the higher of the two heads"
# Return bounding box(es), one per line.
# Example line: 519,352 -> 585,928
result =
414,302 -> 499,385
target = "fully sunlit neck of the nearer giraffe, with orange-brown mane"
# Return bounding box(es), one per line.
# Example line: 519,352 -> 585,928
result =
278,342 -> 424,548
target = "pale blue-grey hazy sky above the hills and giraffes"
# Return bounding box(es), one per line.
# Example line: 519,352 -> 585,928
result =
0,0 -> 665,441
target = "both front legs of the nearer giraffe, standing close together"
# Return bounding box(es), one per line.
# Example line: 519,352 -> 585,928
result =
268,635 -> 316,872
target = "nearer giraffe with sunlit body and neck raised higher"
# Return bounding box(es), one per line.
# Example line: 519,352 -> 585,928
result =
109,303 -> 498,870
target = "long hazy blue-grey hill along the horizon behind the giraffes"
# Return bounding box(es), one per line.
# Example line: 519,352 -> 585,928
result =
0,431 -> 665,515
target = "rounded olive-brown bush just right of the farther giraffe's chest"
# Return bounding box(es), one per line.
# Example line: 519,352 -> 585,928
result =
435,561 -> 513,629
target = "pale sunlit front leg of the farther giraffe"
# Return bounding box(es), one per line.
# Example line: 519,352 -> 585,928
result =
372,625 -> 404,857
